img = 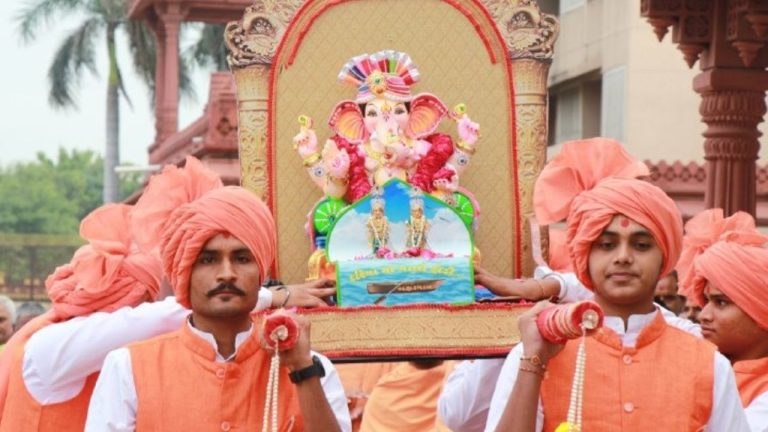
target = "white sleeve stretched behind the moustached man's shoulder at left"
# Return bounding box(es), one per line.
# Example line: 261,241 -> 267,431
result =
22,288 -> 272,405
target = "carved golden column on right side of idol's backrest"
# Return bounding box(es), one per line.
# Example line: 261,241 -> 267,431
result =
484,0 -> 560,268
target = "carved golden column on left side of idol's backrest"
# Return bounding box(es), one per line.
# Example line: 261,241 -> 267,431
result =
224,0 -> 302,202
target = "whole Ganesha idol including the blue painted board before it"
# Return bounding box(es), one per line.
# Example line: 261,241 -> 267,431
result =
293,50 -> 479,306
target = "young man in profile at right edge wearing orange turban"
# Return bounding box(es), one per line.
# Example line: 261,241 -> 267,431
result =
680,209 -> 768,432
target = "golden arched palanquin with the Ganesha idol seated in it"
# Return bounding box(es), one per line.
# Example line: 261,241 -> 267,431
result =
225,0 -> 557,358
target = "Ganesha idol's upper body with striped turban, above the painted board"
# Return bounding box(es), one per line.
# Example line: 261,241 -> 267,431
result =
294,51 -> 478,203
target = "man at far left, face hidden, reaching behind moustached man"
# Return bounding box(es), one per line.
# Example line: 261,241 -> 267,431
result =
0,159 -> 336,432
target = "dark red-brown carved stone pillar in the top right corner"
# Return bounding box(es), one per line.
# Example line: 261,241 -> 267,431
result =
641,0 -> 768,215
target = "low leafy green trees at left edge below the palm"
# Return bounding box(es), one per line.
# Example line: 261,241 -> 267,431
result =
0,149 -> 143,286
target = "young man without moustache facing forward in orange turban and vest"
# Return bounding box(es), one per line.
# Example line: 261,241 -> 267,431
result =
486,155 -> 747,431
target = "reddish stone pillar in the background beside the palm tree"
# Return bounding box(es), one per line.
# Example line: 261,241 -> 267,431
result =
155,1 -> 186,144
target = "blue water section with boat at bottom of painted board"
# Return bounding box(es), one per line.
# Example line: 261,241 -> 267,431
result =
336,257 -> 475,306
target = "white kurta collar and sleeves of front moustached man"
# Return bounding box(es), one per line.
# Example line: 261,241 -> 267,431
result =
85,324 -> 352,432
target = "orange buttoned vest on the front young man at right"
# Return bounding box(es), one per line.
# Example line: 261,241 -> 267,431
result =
541,313 -> 715,432
